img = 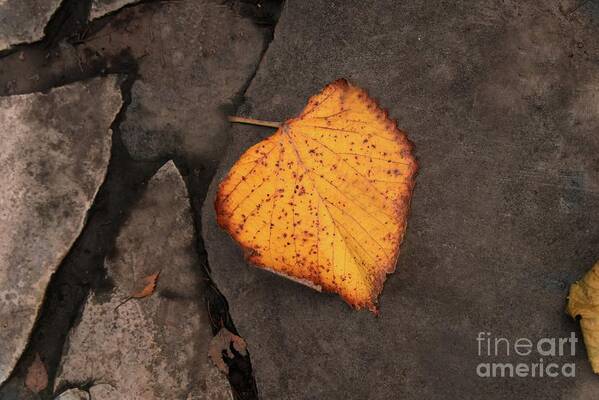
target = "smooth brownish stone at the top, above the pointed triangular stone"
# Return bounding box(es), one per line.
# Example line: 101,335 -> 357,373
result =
81,0 -> 266,169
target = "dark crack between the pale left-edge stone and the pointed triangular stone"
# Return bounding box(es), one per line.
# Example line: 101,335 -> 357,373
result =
0,61 -> 161,399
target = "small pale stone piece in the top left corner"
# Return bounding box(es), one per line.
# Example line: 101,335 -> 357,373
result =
0,0 -> 62,51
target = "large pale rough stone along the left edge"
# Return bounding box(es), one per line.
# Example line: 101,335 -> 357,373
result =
0,77 -> 122,383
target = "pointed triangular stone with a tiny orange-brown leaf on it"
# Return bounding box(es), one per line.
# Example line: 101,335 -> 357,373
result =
55,161 -> 231,400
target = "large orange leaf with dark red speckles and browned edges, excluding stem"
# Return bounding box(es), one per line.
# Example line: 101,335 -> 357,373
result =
216,79 -> 417,312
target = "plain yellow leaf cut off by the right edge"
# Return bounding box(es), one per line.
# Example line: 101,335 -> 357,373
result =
566,262 -> 599,374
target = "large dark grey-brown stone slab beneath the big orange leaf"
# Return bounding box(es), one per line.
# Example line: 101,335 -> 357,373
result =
204,0 -> 599,400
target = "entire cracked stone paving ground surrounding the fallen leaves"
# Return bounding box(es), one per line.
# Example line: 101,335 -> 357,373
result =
0,0 -> 599,400
